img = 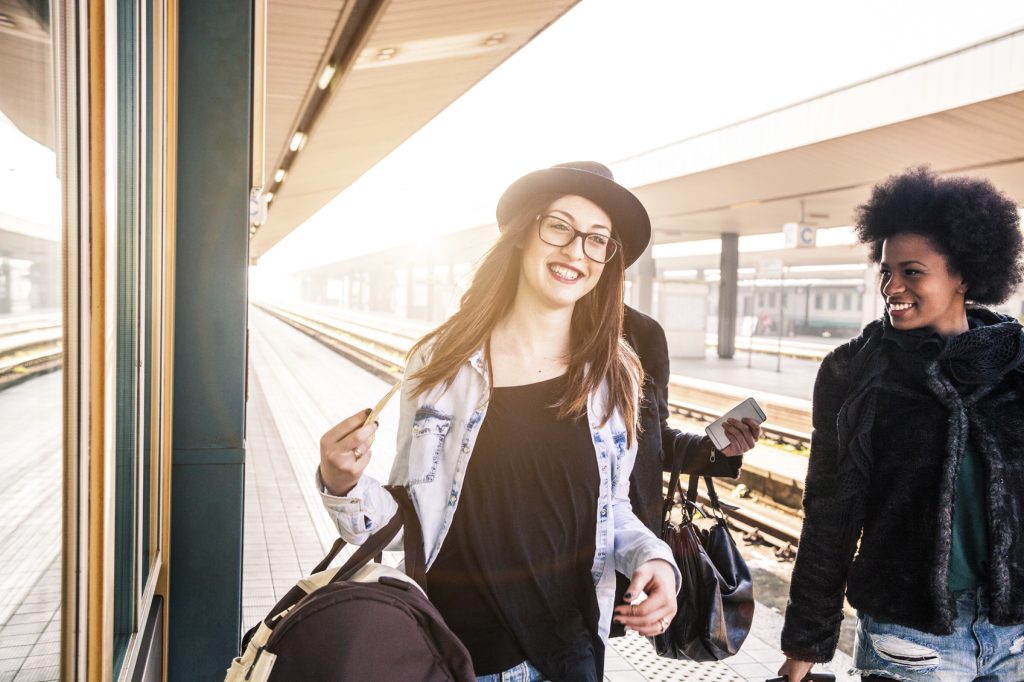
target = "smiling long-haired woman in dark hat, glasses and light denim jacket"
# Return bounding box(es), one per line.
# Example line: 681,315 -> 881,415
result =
317,162 -> 680,680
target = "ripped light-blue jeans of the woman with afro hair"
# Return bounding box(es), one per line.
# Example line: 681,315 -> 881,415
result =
850,589 -> 1024,682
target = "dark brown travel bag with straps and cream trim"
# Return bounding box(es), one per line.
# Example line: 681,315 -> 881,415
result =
225,487 -> 476,682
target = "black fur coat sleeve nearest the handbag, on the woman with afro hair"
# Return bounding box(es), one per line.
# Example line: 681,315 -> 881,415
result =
782,349 -> 865,663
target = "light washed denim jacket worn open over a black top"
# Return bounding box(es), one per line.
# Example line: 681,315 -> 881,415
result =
316,349 -> 682,639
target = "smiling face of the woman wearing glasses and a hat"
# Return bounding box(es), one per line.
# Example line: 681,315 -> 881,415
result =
517,196 -> 620,308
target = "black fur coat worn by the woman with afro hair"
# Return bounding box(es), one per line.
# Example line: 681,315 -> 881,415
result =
782,308 -> 1024,662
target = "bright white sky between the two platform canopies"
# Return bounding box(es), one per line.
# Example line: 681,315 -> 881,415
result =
259,0 -> 1024,274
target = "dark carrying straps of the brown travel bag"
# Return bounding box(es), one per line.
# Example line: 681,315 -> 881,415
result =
313,485 -> 427,590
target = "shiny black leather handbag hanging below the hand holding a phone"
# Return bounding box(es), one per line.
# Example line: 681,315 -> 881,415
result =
649,456 -> 754,660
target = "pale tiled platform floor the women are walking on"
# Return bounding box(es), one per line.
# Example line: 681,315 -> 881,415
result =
243,308 -> 854,682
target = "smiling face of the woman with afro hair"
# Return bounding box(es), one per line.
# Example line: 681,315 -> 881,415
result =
879,233 -> 968,336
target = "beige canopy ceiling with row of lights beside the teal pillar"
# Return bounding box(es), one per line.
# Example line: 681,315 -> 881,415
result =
250,0 -> 578,259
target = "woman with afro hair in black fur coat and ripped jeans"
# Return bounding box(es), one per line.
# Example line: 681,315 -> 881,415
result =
779,168 -> 1024,681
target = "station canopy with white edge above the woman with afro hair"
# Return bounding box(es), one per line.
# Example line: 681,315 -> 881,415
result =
614,29 -> 1024,248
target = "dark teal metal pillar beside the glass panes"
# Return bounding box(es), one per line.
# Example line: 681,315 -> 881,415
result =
168,0 -> 253,682
